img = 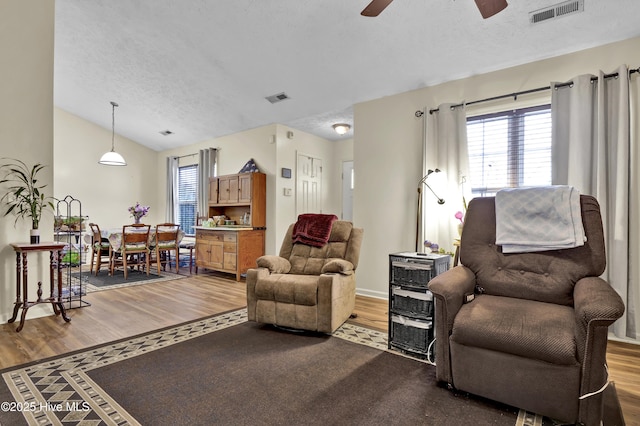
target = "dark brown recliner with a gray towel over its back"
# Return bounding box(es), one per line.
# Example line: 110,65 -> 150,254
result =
429,195 -> 624,425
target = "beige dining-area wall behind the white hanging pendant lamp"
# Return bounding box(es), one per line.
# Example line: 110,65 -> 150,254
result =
53,108 -> 165,229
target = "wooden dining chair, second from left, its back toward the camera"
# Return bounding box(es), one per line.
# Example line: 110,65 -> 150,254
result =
110,223 -> 151,279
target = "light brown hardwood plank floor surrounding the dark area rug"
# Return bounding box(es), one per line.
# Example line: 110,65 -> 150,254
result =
0,273 -> 640,426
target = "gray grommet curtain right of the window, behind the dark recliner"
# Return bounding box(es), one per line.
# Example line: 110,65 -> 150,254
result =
551,66 -> 640,339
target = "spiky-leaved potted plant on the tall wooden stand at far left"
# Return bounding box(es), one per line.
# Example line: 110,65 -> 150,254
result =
0,158 -> 54,244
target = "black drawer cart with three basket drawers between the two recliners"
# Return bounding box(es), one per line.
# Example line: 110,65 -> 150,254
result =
388,252 -> 451,358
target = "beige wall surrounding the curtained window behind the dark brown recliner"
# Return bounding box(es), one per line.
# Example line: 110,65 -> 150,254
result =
354,38 -> 640,297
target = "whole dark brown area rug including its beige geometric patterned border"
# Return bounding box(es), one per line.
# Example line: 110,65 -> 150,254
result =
0,310 -> 624,426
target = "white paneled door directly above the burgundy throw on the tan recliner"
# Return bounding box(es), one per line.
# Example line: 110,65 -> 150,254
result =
296,154 -> 322,215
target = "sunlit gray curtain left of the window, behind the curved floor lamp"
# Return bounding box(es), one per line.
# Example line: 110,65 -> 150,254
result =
416,104 -> 471,252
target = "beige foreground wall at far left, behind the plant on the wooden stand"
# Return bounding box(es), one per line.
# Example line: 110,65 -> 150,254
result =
0,0 -> 54,322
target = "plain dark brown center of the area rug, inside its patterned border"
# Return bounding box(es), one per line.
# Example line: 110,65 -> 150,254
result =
89,323 -> 516,425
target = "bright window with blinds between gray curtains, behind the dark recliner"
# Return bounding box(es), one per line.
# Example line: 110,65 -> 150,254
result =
467,105 -> 551,197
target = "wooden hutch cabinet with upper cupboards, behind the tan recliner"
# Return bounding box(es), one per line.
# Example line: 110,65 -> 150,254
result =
196,173 -> 267,281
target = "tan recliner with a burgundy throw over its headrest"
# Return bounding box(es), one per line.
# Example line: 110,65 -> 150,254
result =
247,221 -> 364,333
